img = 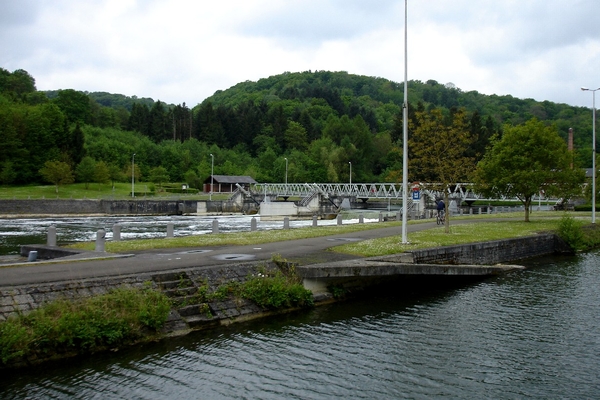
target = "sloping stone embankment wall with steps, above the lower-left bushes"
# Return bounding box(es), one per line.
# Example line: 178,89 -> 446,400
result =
0,262 -> 273,334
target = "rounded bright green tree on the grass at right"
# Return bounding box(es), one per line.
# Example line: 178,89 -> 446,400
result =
475,118 -> 585,222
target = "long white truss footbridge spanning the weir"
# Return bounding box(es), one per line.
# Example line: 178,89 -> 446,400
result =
249,183 -> 555,202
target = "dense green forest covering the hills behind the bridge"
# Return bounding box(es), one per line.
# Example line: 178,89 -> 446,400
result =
0,68 -> 592,187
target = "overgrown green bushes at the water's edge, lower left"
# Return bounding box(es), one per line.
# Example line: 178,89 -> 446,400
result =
0,288 -> 171,363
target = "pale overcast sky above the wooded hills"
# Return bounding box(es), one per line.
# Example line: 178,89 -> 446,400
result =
0,0 -> 600,108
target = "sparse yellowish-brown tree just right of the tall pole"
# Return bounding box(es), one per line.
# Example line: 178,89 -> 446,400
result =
409,109 -> 475,233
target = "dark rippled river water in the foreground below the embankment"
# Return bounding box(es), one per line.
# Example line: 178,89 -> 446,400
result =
0,251 -> 600,400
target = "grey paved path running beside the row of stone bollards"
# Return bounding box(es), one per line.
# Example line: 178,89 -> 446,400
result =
0,219 -> 496,287
